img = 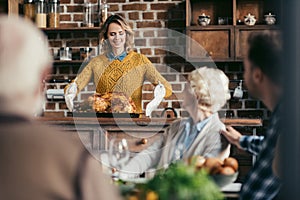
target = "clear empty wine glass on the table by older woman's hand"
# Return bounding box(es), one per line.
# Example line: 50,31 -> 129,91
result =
108,138 -> 130,179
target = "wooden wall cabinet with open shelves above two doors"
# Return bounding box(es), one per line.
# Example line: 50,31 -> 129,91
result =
186,0 -> 281,62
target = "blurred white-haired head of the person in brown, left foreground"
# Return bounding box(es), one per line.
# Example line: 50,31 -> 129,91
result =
0,15 -> 51,115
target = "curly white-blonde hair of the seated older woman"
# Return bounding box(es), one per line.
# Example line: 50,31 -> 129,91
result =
188,67 -> 230,113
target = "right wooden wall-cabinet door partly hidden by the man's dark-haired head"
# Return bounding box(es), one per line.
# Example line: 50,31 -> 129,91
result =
235,25 -> 279,61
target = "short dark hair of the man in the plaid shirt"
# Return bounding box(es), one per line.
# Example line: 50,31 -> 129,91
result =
248,30 -> 283,85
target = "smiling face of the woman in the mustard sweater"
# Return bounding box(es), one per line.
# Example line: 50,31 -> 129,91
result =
107,23 -> 126,52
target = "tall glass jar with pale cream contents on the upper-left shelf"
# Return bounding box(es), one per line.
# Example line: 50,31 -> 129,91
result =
35,0 -> 47,28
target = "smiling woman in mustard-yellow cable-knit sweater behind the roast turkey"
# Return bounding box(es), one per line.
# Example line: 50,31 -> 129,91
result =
65,15 -> 172,113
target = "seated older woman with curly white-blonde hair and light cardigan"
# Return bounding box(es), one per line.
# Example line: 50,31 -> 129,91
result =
121,67 -> 230,175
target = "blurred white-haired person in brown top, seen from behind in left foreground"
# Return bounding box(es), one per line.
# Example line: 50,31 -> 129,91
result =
0,15 -> 119,200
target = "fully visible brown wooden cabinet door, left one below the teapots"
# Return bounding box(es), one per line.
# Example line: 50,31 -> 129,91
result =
186,26 -> 234,62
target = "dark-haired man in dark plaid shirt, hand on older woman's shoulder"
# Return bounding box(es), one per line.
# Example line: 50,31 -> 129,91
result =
221,31 -> 283,200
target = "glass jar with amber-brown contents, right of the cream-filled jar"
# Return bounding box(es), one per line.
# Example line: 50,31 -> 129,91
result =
47,0 -> 60,28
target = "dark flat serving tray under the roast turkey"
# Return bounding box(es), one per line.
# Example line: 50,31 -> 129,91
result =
67,112 -> 140,118
